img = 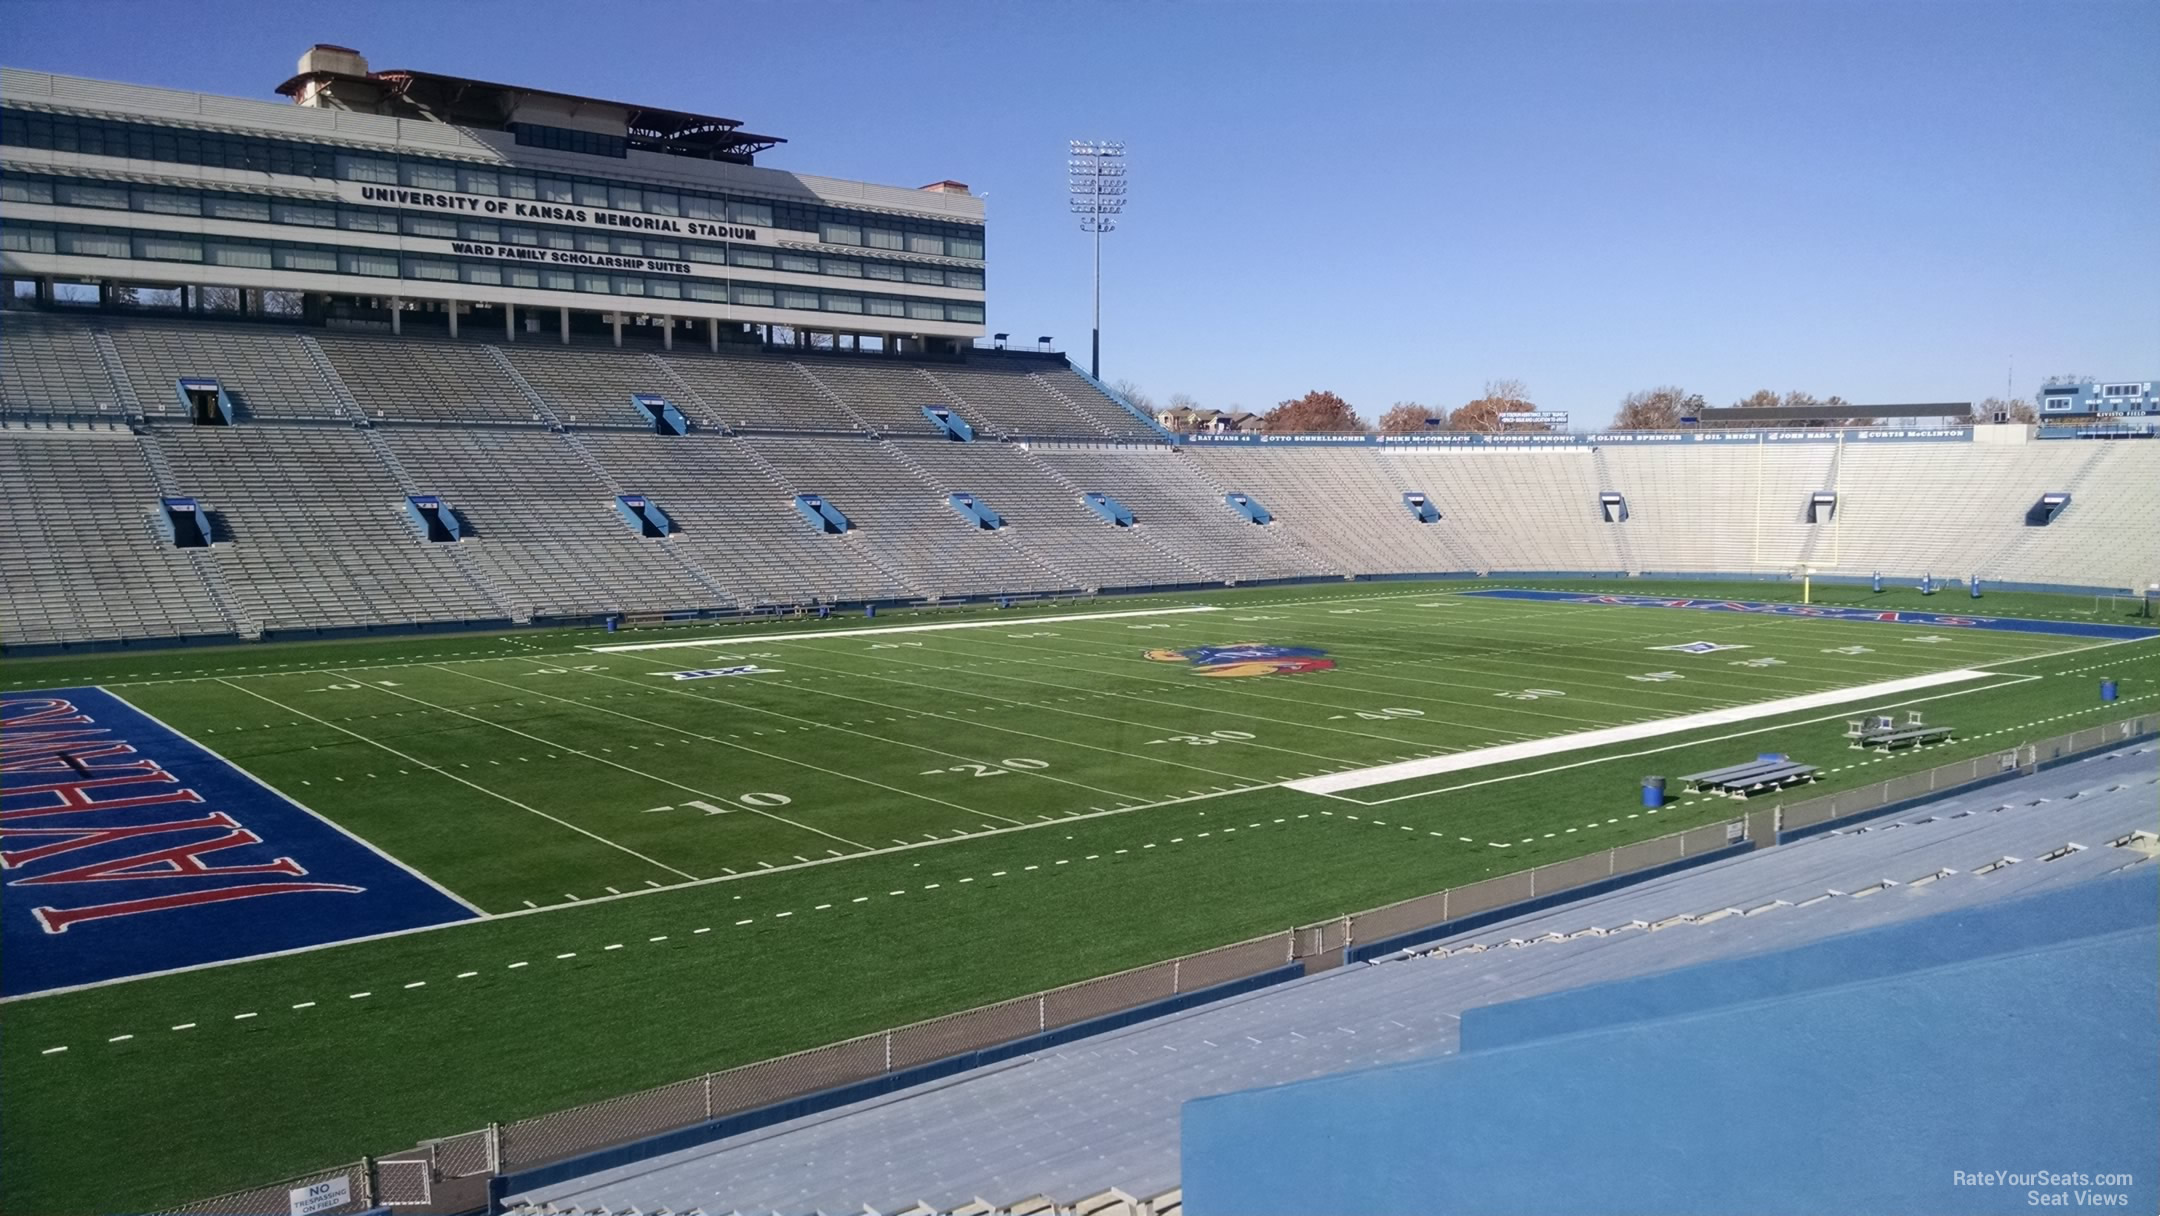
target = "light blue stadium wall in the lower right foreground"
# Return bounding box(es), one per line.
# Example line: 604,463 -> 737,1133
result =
1182,866 -> 2160,1216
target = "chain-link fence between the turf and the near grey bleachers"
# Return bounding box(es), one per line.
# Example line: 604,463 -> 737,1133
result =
166,715 -> 2160,1216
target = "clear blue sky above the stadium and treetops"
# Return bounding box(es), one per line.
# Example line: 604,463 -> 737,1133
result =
0,0 -> 2160,425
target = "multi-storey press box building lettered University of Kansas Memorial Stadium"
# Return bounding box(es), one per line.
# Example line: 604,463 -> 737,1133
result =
0,45 -> 983,352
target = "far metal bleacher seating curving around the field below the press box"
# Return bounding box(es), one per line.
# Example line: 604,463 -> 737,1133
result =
0,309 -> 2160,646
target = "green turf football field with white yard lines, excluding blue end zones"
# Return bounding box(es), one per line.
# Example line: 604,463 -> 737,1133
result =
0,581 -> 2160,1214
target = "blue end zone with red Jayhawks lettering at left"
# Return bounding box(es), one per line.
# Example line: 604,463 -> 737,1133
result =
0,689 -> 477,996
